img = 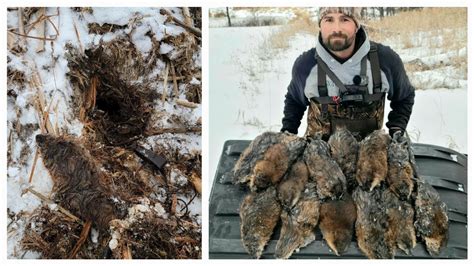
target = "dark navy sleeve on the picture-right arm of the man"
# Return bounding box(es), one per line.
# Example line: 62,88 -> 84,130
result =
386,48 -> 415,130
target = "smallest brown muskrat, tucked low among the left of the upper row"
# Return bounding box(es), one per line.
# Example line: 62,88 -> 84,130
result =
278,159 -> 309,210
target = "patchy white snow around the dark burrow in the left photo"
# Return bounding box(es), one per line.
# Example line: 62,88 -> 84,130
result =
4,7 -> 202,258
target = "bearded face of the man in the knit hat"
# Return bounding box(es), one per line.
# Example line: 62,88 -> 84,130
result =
321,13 -> 357,52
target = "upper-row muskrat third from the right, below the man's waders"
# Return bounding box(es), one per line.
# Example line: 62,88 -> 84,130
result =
328,127 -> 359,193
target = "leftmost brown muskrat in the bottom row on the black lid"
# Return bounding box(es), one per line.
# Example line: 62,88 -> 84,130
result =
240,187 -> 281,258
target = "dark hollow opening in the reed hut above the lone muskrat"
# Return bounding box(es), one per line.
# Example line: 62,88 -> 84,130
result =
68,39 -> 158,146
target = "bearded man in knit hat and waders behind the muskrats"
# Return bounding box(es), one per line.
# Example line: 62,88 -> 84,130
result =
281,7 -> 415,140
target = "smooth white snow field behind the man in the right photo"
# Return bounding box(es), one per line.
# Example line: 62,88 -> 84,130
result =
208,22 -> 467,186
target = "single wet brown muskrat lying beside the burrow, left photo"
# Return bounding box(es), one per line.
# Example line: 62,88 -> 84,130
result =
36,135 -> 115,229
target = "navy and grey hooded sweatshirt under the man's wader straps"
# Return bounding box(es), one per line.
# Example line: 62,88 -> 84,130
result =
281,28 -> 415,134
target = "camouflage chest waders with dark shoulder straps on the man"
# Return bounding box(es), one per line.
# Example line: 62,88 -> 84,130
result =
306,43 -> 385,140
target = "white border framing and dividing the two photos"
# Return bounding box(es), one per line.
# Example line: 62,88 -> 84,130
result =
0,0 -> 474,266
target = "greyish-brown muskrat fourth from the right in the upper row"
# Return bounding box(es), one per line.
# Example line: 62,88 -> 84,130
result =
303,138 -> 346,199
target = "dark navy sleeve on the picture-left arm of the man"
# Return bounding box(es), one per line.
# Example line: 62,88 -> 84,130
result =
281,52 -> 309,134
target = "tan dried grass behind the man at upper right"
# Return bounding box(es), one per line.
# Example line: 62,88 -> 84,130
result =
366,7 -> 467,76
